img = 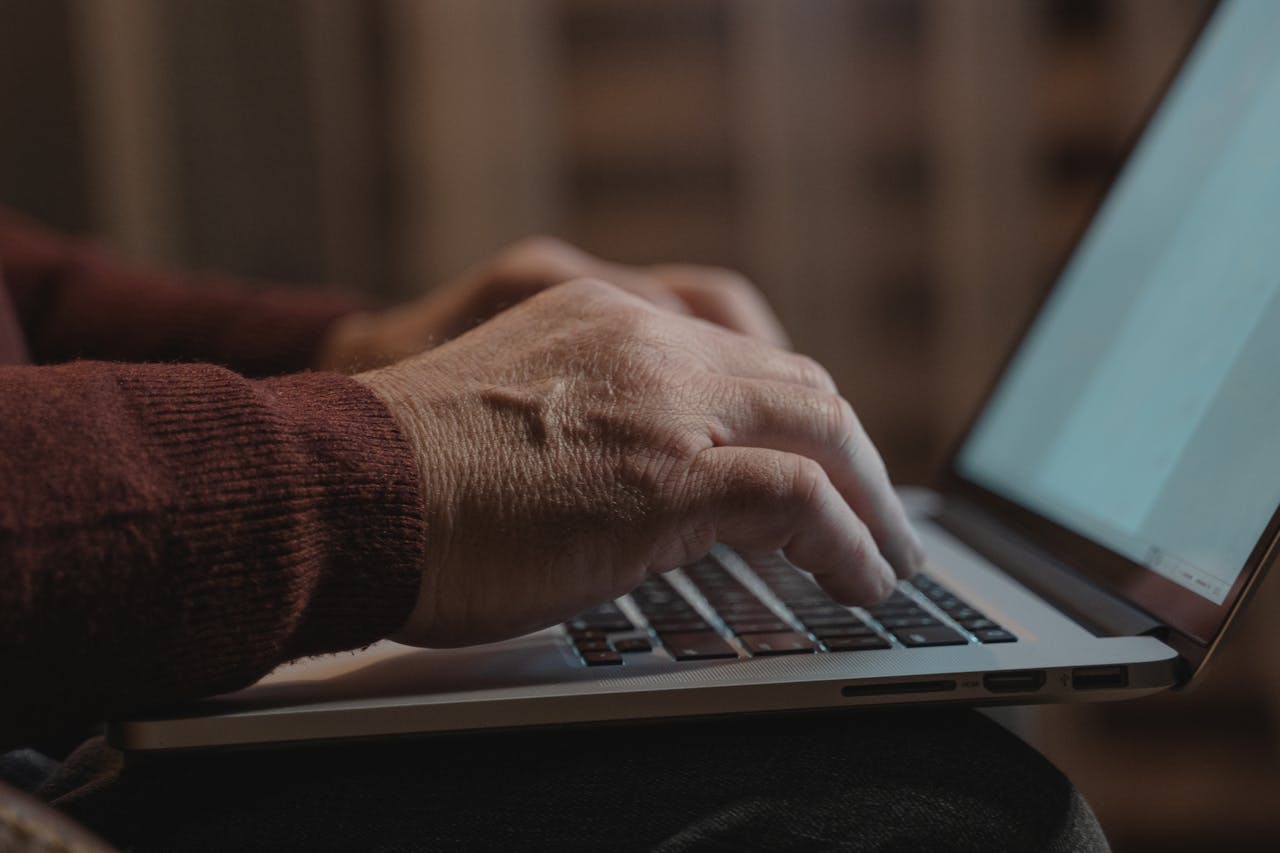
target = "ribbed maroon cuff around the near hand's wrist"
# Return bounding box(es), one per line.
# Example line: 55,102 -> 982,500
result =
120,366 -> 425,688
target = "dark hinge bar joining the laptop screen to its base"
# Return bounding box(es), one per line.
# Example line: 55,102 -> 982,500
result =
936,496 -> 1169,639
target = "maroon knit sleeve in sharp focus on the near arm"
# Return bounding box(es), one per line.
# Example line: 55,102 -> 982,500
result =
0,362 -> 425,742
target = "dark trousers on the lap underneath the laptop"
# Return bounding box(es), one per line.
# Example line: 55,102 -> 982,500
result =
35,710 -> 1107,853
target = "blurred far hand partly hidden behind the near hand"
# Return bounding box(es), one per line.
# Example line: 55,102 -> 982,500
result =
317,237 -> 787,371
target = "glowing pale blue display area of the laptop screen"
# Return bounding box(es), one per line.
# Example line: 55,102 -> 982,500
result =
957,0 -> 1280,605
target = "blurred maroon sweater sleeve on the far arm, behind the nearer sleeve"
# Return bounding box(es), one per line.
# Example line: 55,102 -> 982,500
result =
0,210 -> 364,377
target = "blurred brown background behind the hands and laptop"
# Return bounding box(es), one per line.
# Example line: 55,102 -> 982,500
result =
0,0 -> 1280,850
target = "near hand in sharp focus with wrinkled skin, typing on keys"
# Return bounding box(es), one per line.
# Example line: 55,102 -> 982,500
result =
356,279 -> 920,646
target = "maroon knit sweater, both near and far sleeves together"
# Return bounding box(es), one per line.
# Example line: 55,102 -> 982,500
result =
0,211 -> 425,747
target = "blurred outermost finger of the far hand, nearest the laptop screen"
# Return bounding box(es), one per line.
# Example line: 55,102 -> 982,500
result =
648,264 -> 791,350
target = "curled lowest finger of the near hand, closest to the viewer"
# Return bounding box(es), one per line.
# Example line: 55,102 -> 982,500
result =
681,447 -> 897,605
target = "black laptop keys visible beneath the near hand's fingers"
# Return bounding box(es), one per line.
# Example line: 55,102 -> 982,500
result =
564,555 -> 1018,666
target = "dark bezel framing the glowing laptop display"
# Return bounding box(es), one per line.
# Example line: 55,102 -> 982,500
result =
943,1 -> 1280,647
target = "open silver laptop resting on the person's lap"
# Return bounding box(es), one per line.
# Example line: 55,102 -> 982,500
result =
108,0 -> 1280,753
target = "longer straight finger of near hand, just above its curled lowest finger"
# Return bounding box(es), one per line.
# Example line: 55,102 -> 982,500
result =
712,380 -> 923,578
